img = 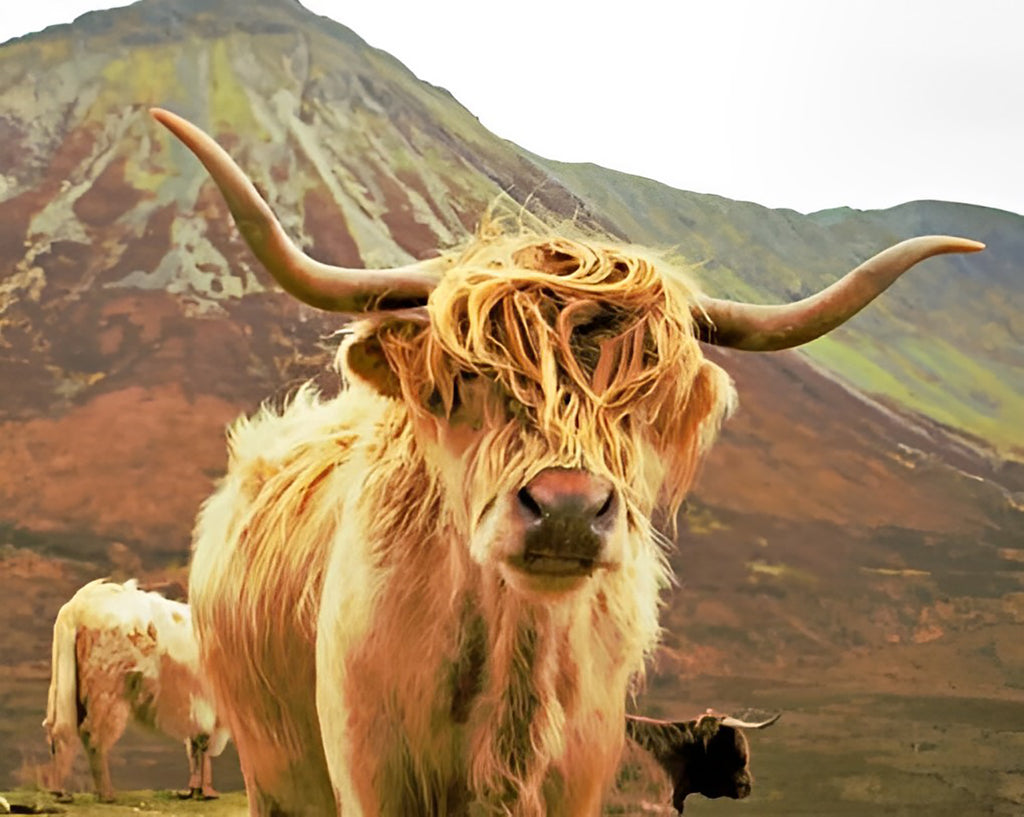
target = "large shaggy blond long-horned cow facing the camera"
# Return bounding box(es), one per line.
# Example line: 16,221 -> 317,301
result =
146,110 -> 982,817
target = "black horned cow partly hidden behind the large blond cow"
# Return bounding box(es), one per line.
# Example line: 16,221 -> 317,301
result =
626,712 -> 779,814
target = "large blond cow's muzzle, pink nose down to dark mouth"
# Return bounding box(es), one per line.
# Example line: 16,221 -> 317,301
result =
510,468 -> 618,576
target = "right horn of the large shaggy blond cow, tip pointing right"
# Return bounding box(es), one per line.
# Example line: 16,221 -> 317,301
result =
692,235 -> 985,352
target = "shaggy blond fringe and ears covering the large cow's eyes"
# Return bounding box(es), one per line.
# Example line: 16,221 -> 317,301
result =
374,221 -> 734,520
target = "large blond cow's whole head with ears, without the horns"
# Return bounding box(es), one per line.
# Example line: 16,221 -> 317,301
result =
345,238 -> 732,594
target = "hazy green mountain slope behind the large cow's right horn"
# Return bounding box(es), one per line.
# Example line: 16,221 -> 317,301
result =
532,162 -> 1024,459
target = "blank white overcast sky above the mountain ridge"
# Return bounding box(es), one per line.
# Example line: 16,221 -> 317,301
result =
0,0 -> 1024,214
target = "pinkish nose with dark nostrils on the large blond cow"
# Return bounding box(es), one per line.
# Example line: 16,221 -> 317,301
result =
517,468 -> 615,532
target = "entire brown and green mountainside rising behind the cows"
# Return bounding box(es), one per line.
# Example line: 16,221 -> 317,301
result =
0,0 -> 1024,815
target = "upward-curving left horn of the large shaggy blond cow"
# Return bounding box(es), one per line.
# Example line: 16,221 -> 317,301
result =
150,108 -> 444,312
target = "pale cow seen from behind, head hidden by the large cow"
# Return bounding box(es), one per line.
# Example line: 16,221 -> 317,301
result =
43,578 -> 228,802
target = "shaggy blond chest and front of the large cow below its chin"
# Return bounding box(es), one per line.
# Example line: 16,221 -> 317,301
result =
317,442 -> 634,817
